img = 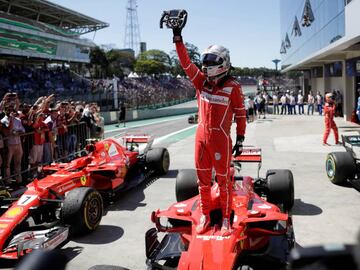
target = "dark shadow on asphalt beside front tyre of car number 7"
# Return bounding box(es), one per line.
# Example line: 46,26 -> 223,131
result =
71,225 -> 124,245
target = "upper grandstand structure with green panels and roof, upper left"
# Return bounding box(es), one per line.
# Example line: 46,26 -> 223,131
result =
0,0 -> 109,63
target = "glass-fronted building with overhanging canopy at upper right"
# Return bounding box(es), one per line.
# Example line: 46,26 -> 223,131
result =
280,0 -> 360,120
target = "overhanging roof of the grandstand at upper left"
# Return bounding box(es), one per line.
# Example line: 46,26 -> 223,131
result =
0,0 -> 109,35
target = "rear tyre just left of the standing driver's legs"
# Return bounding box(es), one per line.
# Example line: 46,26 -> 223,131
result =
175,169 -> 199,202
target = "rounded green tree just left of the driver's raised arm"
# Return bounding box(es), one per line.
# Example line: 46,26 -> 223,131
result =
135,50 -> 171,74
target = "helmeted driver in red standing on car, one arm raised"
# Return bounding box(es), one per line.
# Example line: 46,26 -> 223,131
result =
173,22 -> 246,236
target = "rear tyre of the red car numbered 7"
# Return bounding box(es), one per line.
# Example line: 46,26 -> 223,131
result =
146,147 -> 170,175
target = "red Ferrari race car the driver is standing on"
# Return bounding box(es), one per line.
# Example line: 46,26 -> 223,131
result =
145,149 -> 295,270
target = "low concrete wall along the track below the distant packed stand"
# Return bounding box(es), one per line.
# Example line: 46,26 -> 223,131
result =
101,107 -> 197,125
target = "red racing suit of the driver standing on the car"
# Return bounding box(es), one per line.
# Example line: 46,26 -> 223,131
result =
176,42 -> 246,218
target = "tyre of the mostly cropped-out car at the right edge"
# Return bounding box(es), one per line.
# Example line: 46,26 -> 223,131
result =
325,152 -> 356,185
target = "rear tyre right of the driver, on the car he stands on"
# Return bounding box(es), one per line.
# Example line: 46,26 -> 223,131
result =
266,170 -> 294,211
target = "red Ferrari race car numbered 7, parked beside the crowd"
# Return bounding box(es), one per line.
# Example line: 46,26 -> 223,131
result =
0,135 -> 170,259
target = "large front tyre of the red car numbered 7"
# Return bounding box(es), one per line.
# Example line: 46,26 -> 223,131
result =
61,187 -> 103,234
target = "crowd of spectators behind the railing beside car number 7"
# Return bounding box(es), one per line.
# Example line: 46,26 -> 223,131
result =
0,93 -> 104,184
